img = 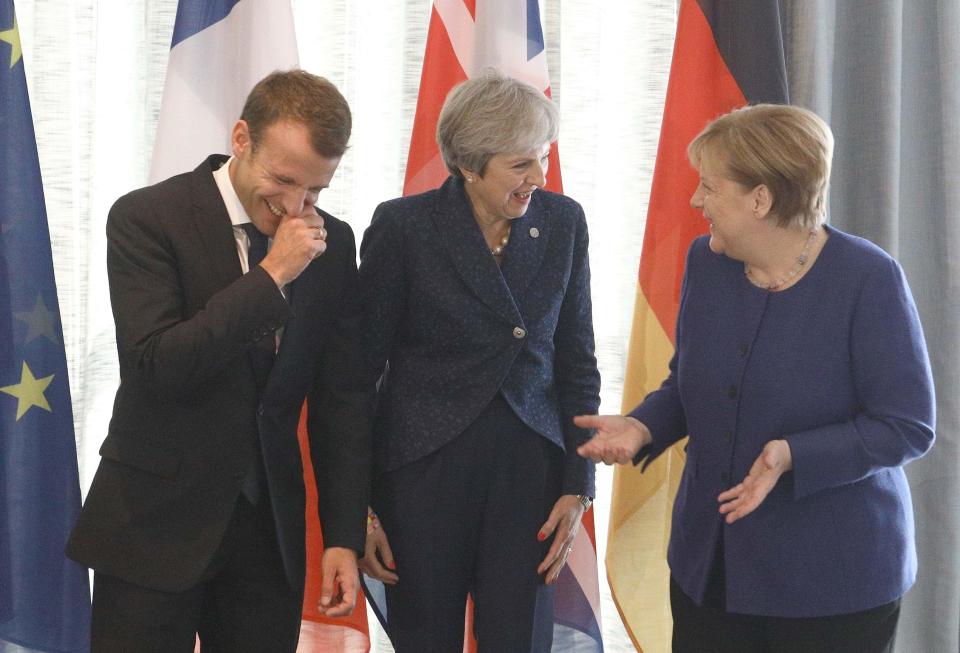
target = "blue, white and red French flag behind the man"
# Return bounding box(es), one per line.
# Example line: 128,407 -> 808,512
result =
150,0 -> 370,653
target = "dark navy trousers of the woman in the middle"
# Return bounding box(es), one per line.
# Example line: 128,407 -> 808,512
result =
376,395 -> 563,653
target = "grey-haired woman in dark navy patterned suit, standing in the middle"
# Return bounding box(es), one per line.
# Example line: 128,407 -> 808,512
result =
360,72 -> 600,653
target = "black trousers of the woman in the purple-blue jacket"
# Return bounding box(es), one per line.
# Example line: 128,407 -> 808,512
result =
670,578 -> 900,653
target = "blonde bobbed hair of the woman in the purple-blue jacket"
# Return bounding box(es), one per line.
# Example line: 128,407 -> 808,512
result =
687,104 -> 833,229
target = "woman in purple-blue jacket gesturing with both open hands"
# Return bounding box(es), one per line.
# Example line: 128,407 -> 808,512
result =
576,105 -> 934,653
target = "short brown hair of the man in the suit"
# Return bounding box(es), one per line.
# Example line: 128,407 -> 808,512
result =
240,69 -> 353,159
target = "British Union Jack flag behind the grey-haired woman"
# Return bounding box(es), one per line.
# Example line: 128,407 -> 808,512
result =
380,0 -> 603,653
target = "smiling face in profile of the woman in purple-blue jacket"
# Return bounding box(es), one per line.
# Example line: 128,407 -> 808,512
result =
690,151 -> 769,260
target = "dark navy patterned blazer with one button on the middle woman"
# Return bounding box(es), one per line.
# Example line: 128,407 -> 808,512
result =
360,177 -> 600,496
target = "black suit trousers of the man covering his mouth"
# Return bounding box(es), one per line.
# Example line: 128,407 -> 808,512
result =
91,496 -> 303,653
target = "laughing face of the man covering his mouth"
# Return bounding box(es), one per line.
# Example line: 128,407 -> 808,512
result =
230,120 -> 340,237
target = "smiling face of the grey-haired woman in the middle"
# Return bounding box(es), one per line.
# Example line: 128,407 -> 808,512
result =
461,143 -> 550,224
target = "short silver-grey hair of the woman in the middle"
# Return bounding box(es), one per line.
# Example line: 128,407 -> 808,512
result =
437,69 -> 560,177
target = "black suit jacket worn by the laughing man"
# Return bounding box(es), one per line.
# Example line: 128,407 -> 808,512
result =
67,155 -> 372,592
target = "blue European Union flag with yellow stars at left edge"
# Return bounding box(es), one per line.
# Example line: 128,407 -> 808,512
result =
0,0 -> 90,653
